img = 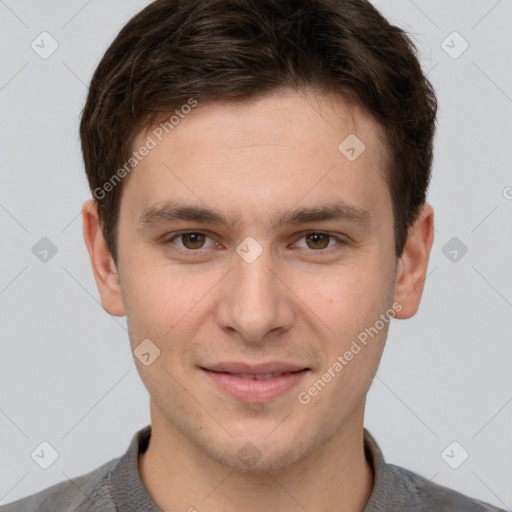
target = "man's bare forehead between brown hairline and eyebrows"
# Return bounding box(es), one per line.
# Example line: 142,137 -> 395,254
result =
123,91 -> 390,228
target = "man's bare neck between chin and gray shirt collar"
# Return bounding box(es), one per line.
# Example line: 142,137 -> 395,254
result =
139,404 -> 374,512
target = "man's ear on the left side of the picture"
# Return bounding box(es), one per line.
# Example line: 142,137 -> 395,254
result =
82,199 -> 125,316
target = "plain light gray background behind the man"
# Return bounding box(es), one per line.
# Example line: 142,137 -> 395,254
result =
0,0 -> 512,510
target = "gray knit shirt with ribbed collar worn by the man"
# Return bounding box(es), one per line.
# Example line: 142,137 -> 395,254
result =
0,425 -> 504,512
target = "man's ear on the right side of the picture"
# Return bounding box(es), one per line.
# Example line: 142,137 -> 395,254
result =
395,203 -> 434,318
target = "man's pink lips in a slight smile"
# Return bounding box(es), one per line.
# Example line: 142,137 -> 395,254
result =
201,361 -> 310,403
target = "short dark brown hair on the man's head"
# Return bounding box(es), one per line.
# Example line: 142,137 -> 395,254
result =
80,0 -> 437,261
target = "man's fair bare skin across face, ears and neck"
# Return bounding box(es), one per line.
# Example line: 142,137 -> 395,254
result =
83,90 -> 433,512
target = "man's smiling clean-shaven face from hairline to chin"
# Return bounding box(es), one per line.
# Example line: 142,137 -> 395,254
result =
88,91 -> 416,471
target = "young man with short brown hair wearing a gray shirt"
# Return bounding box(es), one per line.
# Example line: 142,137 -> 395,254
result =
4,0 -> 508,512
